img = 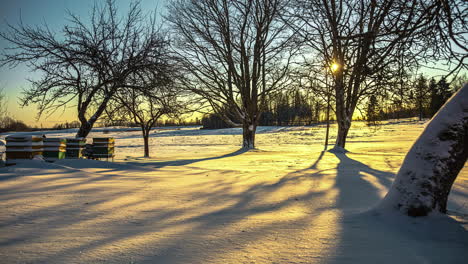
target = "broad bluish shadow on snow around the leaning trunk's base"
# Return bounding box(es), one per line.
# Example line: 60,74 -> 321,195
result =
328,153 -> 468,264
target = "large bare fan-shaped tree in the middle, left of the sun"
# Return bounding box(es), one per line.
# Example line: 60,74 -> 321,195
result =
167,0 -> 296,149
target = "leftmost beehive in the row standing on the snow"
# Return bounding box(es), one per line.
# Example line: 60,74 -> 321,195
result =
5,135 -> 43,162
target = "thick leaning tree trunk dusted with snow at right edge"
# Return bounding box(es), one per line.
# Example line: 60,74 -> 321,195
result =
378,84 -> 468,216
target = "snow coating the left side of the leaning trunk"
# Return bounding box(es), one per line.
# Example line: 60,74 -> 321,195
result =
378,84 -> 468,214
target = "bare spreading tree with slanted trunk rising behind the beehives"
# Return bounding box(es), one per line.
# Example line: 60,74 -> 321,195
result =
0,0 -> 165,137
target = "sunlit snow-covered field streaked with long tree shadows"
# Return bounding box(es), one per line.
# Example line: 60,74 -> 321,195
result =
0,120 -> 468,264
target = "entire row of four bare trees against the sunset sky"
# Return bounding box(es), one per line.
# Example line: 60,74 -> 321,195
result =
0,0 -> 468,153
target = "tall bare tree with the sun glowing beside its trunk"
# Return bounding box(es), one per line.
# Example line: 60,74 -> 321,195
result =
288,0 -> 466,149
